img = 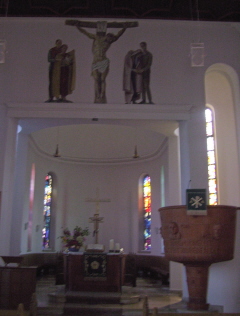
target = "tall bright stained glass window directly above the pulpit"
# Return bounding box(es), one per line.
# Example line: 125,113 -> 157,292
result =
205,108 -> 218,205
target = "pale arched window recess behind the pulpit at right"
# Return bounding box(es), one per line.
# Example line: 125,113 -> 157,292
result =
205,64 -> 239,205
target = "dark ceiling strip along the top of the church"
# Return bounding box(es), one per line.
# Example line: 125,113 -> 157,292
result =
0,0 -> 240,22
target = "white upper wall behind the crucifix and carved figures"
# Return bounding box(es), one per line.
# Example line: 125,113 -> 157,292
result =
0,18 -> 240,106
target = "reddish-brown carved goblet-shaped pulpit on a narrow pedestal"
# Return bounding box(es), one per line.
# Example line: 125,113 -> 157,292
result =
159,205 -> 238,310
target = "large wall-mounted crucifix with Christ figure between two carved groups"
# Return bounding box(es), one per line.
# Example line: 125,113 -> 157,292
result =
65,20 -> 138,103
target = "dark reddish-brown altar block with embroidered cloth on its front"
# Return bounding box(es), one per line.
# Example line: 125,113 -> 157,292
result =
64,252 -> 125,292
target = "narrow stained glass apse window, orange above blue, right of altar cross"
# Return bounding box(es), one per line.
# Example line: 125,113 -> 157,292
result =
143,175 -> 152,250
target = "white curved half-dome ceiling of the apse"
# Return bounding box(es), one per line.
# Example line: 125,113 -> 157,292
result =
24,120 -> 178,162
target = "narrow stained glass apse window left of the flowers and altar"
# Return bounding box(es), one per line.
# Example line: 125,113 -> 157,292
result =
42,174 -> 52,249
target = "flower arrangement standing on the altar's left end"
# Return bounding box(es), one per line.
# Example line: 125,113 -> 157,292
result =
60,226 -> 89,251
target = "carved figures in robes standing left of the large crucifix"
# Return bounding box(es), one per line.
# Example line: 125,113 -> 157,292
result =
46,39 -> 76,102
